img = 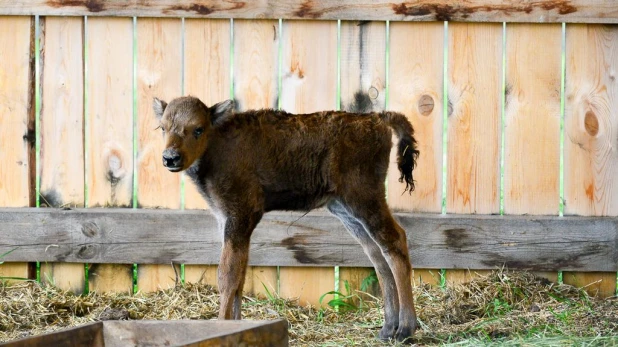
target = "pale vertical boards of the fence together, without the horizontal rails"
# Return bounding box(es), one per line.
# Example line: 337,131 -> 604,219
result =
0,1 -> 618,304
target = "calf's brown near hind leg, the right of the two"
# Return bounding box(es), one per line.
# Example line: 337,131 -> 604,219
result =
344,194 -> 417,341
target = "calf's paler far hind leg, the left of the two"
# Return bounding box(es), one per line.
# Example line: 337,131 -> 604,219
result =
327,200 -> 399,340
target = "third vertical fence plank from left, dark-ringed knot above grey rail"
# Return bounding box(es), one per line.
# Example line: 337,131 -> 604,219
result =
85,17 -> 133,291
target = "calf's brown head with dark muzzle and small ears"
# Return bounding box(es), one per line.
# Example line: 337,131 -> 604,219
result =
153,96 -> 234,172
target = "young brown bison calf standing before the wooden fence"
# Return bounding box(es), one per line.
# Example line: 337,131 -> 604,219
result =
153,97 -> 419,341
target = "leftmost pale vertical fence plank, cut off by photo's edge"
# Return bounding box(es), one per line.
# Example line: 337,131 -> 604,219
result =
0,16 -> 35,279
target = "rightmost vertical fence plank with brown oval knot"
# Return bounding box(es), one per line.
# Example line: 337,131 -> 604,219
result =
563,24 -> 618,297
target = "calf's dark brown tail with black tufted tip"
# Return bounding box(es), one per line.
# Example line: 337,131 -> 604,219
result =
380,112 -> 419,194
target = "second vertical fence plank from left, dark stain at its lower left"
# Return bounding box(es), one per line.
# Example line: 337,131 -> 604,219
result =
39,17 -> 85,294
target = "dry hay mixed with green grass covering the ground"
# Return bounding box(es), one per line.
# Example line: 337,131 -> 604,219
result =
0,271 -> 618,346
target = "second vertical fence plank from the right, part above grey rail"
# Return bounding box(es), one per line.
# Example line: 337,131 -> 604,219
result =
504,24 -> 562,215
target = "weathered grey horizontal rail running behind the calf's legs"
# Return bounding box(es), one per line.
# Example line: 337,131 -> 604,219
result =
0,208 -> 618,271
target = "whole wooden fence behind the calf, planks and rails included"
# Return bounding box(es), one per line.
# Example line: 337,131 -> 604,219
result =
0,0 -> 618,303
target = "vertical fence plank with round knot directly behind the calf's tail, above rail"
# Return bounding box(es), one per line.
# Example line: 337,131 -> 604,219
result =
387,23 -> 444,212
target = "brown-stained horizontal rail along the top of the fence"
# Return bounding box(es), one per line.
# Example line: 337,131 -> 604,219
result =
0,0 -> 618,23
